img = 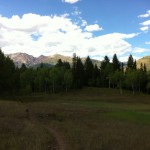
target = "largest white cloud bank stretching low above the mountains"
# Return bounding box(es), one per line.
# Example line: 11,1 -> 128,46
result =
0,14 -> 144,58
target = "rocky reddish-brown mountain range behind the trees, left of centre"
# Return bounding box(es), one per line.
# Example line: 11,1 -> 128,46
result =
7,53 -> 101,67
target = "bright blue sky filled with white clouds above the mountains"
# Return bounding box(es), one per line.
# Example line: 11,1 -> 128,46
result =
0,0 -> 150,61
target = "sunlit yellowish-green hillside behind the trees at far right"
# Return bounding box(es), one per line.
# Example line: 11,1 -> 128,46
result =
137,56 -> 150,70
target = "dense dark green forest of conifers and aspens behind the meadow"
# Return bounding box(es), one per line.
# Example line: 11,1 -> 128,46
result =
0,49 -> 150,95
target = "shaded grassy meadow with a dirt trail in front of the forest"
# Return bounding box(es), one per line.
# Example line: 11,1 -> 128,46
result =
0,88 -> 150,150
